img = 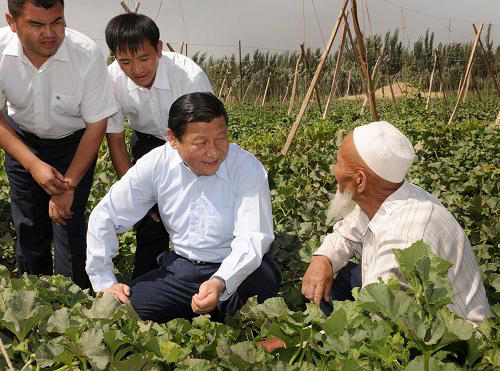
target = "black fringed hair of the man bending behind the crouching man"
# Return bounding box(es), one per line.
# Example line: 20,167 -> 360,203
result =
105,13 -> 160,55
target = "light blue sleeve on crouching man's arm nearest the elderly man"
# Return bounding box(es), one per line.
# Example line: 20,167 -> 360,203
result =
214,160 -> 274,301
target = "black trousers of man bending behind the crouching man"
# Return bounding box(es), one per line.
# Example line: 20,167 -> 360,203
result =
131,131 -> 169,279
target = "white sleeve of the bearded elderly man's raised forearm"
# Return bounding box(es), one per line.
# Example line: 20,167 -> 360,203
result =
314,206 -> 362,273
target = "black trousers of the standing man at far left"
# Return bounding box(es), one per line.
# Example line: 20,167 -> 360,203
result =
5,115 -> 95,288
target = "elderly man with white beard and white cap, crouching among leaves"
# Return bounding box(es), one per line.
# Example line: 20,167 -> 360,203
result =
302,121 -> 491,323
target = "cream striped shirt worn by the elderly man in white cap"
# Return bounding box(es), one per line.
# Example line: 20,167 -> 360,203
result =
315,181 -> 491,323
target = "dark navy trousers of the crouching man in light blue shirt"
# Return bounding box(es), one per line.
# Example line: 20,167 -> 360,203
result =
130,252 -> 281,323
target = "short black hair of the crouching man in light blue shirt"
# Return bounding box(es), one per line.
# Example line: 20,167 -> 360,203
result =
168,92 -> 228,141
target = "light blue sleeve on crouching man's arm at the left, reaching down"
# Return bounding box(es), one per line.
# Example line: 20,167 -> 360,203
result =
85,156 -> 157,292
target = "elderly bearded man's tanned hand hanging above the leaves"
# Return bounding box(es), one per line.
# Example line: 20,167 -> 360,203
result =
302,255 -> 333,307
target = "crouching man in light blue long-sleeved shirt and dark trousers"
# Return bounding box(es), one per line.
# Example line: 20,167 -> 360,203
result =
86,93 -> 281,322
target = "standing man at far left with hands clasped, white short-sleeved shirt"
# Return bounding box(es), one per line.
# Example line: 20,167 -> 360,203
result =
0,0 -> 117,288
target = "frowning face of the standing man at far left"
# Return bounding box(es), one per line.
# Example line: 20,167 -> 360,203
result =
5,2 -> 65,68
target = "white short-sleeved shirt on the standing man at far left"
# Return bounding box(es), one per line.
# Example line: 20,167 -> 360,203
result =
0,27 -> 118,139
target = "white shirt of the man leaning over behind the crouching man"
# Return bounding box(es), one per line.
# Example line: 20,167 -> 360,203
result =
107,52 -> 213,140
